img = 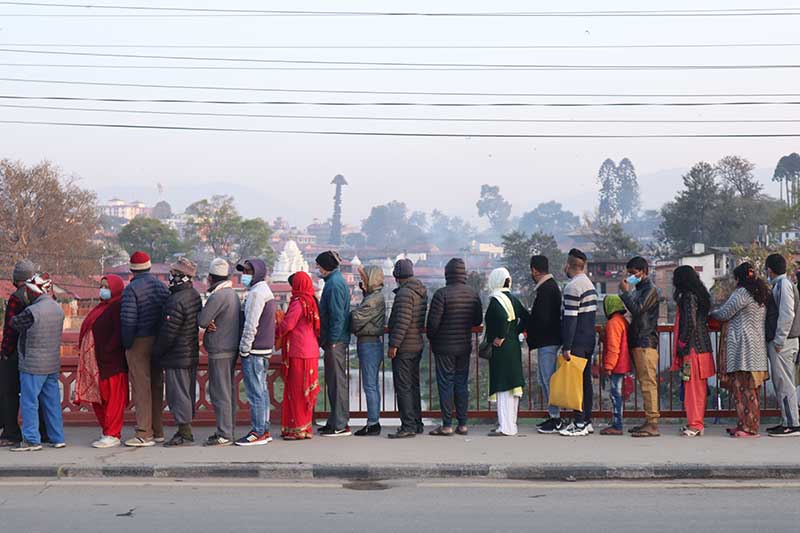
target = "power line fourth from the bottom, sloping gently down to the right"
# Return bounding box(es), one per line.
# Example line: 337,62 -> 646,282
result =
6,78 -> 800,98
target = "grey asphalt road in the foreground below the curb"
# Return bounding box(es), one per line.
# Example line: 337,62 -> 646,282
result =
0,479 -> 800,533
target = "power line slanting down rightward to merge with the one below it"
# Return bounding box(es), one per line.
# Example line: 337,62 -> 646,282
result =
0,48 -> 800,70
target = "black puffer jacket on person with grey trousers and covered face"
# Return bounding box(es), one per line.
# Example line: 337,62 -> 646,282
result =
153,283 -> 202,368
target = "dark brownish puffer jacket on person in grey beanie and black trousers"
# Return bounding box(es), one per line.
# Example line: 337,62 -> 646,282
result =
389,278 -> 428,356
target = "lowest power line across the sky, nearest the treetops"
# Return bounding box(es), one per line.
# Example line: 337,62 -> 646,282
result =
6,120 -> 800,139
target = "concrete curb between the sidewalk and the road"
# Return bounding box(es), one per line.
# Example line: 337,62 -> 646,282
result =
0,463 -> 800,481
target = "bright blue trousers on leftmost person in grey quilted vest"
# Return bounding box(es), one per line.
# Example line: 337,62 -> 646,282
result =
19,372 -> 64,444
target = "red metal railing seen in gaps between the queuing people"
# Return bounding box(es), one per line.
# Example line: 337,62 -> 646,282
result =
60,325 -> 780,425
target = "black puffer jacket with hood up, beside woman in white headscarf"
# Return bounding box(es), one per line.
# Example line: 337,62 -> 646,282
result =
428,258 -> 483,357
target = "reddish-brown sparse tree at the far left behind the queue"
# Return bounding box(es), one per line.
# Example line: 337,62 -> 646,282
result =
0,159 -> 102,275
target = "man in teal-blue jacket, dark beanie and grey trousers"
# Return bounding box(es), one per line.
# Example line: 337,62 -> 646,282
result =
317,250 -> 352,437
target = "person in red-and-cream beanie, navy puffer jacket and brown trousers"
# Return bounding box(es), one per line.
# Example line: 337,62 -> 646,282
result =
120,252 -> 169,447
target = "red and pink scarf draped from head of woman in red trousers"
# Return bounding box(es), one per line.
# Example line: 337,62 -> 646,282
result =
75,274 -> 125,403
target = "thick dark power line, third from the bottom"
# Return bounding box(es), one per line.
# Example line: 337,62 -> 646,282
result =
6,95 -> 800,107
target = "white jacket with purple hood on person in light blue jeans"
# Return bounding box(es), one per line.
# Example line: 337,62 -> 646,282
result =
239,259 -> 277,356
